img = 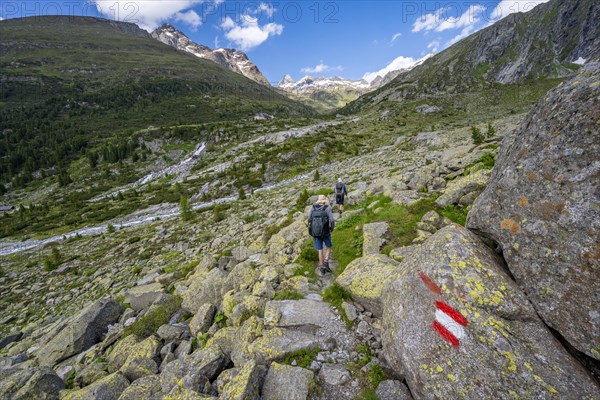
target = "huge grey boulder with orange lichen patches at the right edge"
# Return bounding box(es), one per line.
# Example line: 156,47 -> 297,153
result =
467,63 -> 600,360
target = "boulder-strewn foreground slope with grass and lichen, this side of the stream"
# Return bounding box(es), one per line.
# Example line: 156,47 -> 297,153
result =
0,64 -> 600,399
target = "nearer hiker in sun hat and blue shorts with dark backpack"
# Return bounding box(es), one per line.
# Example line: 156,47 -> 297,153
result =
308,195 -> 335,274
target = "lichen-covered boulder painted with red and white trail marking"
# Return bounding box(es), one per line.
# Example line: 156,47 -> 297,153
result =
382,225 -> 600,399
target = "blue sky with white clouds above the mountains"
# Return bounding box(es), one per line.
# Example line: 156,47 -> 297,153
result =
0,0 -> 547,82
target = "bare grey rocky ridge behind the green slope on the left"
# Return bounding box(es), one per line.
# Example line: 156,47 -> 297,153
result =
152,24 -> 270,86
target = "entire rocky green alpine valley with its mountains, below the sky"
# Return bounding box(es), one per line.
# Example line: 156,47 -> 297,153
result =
0,0 -> 600,400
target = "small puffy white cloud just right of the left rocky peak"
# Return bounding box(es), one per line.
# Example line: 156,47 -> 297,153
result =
220,17 -> 283,51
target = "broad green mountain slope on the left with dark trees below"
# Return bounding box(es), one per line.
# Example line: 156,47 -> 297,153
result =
0,17 -> 310,183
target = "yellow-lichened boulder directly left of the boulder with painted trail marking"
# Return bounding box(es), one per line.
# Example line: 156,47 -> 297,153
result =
336,254 -> 400,316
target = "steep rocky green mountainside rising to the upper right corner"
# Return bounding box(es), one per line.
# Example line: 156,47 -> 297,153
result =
348,0 -> 600,110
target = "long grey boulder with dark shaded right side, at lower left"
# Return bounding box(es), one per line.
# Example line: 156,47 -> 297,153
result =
36,298 -> 123,366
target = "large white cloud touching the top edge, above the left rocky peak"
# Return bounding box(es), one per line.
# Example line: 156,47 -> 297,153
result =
91,0 -> 203,31
